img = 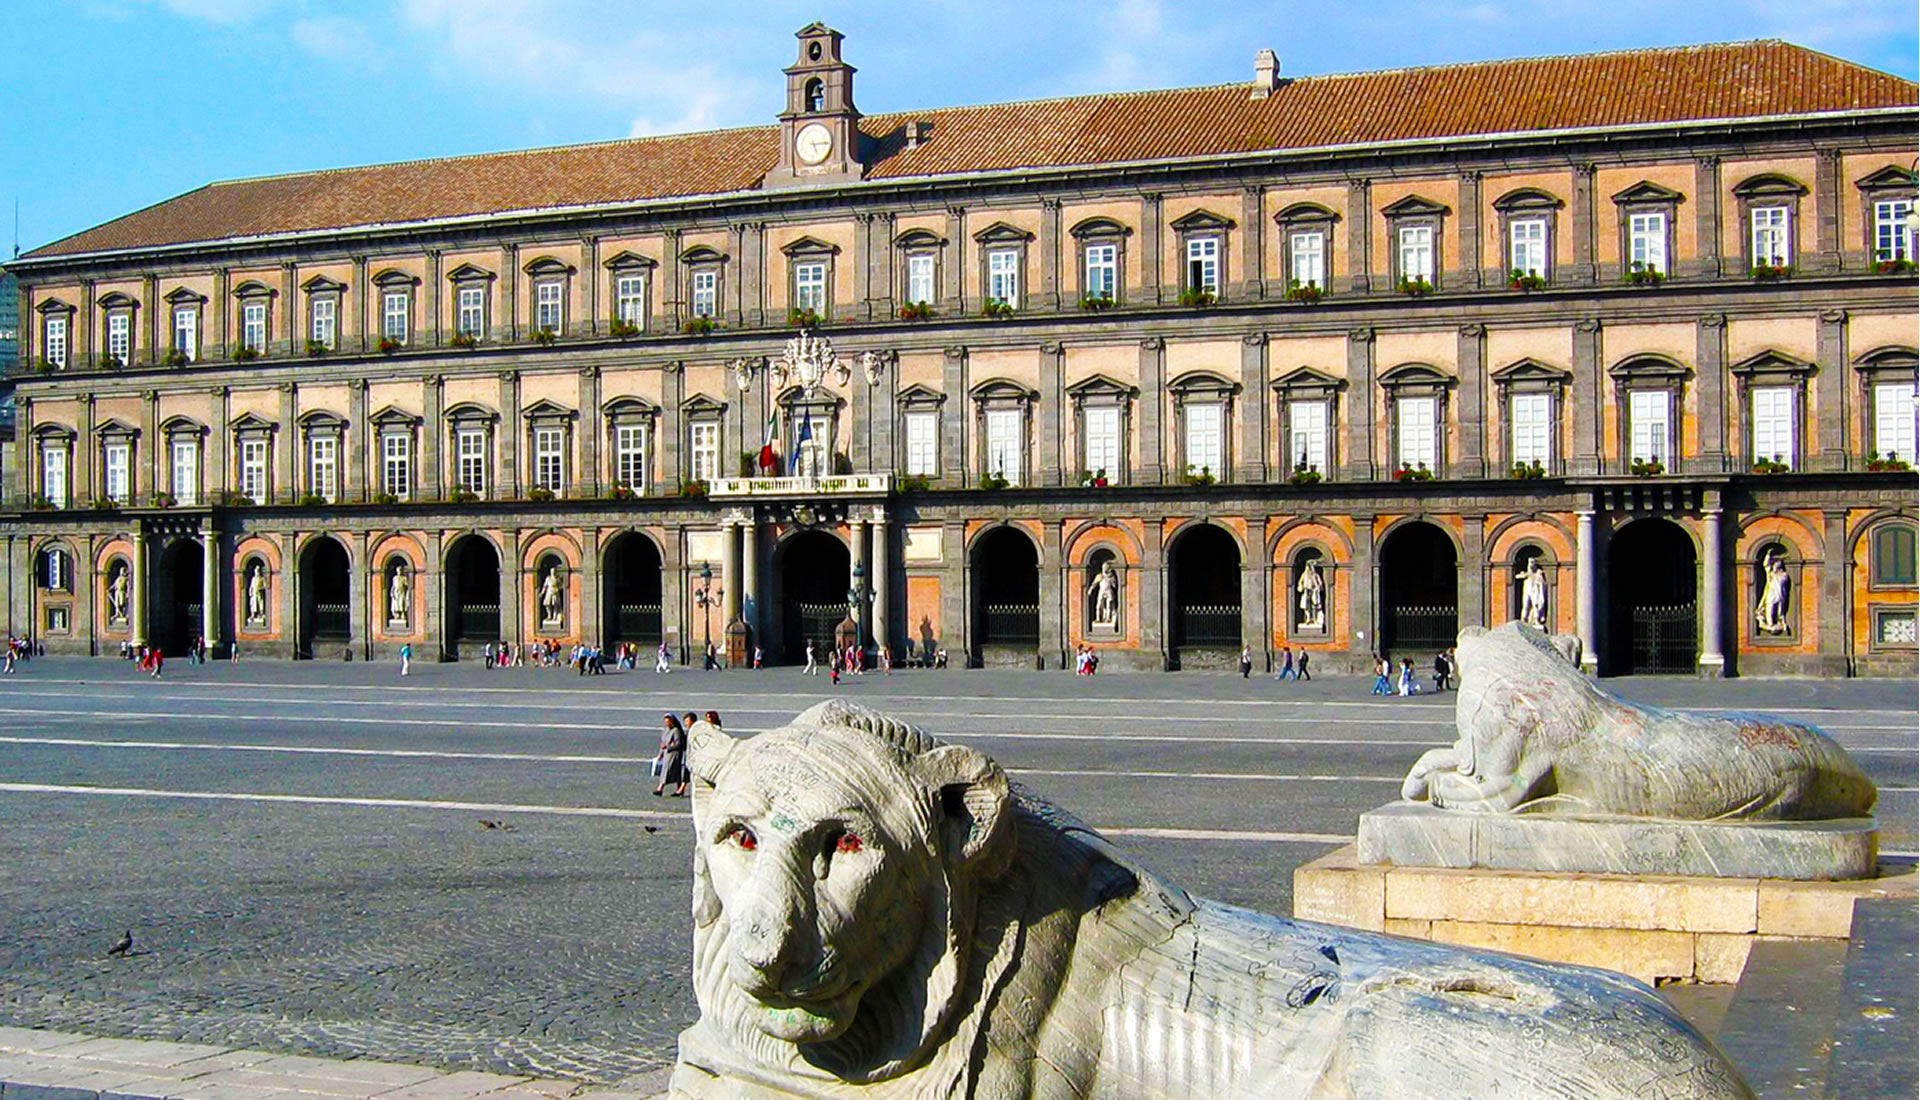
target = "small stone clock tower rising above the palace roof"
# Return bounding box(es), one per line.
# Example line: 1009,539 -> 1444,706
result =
760,23 -> 866,188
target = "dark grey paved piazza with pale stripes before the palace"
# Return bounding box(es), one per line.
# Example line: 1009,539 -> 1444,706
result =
0,658 -> 1916,1081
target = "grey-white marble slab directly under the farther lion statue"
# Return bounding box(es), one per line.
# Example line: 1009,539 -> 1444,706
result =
1357,802 -> 1880,881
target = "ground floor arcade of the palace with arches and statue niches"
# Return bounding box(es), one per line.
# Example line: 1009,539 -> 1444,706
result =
0,476 -> 1916,676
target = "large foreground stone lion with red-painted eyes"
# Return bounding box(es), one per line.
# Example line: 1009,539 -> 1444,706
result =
672,703 -> 1751,1100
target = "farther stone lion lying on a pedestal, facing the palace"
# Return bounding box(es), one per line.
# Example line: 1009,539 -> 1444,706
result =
1400,622 -> 1876,822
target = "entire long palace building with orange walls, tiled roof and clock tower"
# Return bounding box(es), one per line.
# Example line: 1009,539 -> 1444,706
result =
0,25 -> 1920,676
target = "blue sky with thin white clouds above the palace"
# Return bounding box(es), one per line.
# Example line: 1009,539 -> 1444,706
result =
0,0 -> 1920,257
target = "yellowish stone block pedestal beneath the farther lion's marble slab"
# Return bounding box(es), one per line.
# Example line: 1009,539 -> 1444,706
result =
1294,845 -> 1920,983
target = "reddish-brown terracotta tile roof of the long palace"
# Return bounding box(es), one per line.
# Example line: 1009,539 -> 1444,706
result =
27,40 -> 1920,257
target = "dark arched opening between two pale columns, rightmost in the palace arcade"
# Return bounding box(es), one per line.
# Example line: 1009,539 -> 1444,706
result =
1607,520 -> 1699,676
